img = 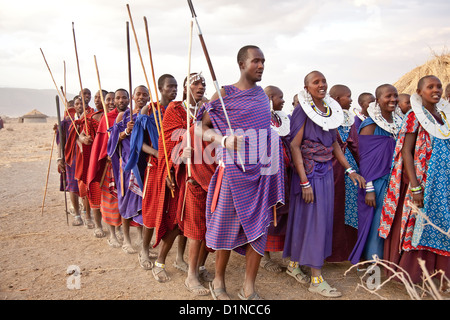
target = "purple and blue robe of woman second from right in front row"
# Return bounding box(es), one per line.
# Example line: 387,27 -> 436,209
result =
349,118 -> 395,264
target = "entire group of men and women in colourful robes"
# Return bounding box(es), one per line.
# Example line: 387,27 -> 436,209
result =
58,46 -> 450,300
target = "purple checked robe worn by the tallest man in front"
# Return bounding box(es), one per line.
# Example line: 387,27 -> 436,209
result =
200,86 -> 284,255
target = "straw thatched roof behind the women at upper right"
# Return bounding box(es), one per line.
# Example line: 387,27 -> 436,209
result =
394,54 -> 450,94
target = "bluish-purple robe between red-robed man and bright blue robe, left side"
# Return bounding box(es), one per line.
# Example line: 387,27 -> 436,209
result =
108,109 -> 142,225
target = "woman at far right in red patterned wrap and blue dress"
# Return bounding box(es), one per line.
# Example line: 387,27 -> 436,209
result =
379,76 -> 450,291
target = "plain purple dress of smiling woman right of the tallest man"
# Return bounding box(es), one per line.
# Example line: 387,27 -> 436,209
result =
283,103 -> 336,269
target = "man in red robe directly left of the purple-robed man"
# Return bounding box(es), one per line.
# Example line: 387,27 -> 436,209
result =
87,92 -> 122,247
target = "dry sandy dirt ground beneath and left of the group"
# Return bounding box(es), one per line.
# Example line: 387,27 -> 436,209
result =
0,118 -> 428,301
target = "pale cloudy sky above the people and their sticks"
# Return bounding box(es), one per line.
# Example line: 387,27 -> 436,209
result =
0,0 -> 450,113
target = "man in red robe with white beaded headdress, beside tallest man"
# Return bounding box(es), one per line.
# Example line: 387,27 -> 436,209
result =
175,73 -> 217,296
